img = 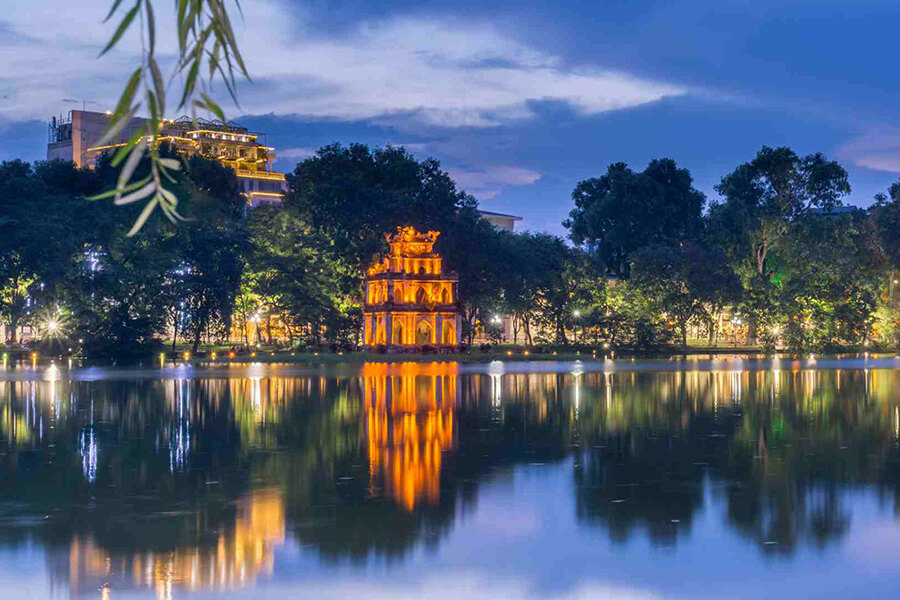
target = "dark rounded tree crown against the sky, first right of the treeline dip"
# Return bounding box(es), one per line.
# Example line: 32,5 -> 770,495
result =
563,158 -> 706,279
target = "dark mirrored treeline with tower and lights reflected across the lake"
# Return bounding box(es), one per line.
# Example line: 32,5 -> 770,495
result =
0,361 -> 900,598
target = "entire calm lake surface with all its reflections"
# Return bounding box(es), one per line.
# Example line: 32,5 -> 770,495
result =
0,357 -> 900,600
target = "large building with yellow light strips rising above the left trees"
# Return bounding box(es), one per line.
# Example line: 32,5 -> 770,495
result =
47,110 -> 286,206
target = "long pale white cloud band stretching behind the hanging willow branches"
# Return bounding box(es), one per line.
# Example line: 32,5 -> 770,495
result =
0,0 -> 687,128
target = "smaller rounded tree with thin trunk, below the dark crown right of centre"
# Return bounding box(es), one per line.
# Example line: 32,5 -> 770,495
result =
632,242 -> 740,348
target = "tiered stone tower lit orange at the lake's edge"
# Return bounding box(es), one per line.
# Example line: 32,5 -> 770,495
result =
363,227 -> 460,347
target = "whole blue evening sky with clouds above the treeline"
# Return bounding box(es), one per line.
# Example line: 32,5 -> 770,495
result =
0,0 -> 900,235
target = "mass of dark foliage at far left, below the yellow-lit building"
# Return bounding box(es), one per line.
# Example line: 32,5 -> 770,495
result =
0,155 -> 247,357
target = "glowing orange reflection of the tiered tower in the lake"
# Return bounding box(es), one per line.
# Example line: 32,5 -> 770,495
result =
362,363 -> 458,510
